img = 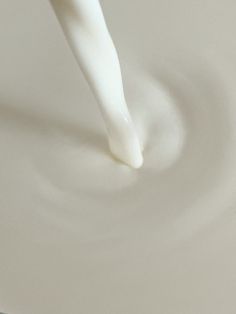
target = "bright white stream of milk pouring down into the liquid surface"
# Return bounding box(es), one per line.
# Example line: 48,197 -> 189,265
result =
48,0 -> 143,168
